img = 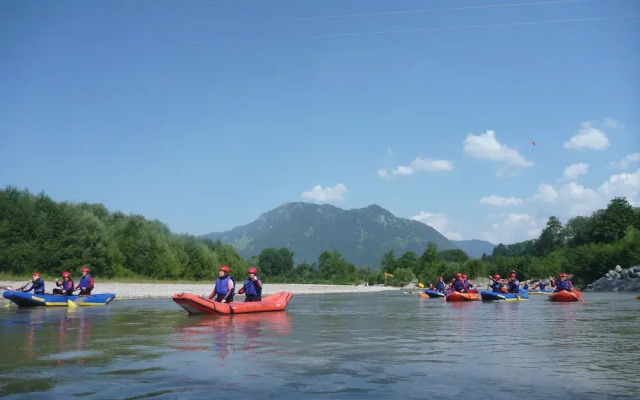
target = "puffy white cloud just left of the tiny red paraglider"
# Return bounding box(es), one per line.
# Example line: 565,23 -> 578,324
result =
464,130 -> 534,168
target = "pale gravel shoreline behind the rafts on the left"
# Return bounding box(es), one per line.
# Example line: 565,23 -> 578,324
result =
0,280 -> 400,301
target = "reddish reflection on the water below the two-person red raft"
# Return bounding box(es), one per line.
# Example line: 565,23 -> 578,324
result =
172,311 -> 293,360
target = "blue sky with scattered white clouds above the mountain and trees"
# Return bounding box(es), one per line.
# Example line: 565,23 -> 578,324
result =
0,0 -> 640,243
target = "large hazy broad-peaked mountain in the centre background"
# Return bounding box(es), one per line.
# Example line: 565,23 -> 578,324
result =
204,202 -> 458,268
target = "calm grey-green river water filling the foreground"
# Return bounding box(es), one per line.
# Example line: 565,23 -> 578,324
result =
0,292 -> 640,400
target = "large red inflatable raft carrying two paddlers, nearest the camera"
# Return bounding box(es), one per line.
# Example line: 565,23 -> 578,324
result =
173,292 -> 293,314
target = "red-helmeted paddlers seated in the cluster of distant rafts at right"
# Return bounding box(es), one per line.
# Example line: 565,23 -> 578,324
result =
427,271 -> 573,294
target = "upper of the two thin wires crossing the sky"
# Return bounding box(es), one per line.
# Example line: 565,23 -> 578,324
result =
184,0 -> 610,28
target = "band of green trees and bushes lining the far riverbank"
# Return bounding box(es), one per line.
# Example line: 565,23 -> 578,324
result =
0,187 -> 640,286
